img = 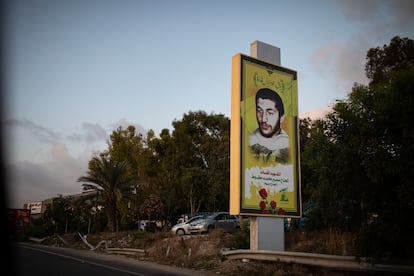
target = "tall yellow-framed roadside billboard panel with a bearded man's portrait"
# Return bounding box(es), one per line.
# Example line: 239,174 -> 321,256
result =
230,54 -> 301,217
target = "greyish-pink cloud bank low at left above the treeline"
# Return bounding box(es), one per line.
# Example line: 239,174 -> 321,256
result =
4,119 -> 150,208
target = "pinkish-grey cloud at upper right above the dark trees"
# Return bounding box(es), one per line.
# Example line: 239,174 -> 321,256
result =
311,0 -> 414,98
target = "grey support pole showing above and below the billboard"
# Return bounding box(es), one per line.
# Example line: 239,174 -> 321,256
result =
250,40 -> 285,251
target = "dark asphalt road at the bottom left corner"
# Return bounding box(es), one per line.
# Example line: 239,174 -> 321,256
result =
12,243 -> 211,276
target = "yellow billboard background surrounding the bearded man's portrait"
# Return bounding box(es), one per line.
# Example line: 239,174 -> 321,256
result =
230,54 -> 301,217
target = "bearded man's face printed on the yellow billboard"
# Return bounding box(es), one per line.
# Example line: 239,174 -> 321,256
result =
256,98 -> 284,138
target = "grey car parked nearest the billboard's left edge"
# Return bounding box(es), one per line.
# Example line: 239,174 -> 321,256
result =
190,212 -> 240,234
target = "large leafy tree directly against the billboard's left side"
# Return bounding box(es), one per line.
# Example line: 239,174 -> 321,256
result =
173,111 -> 230,215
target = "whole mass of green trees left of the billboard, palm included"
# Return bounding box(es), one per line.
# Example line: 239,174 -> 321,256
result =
77,111 -> 230,235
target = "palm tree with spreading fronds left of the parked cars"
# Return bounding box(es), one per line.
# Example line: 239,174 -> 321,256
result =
78,153 -> 134,232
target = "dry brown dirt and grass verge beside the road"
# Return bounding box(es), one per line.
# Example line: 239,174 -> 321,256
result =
33,230 -> 368,276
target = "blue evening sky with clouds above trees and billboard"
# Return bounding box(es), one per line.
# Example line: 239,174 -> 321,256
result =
1,0 -> 414,208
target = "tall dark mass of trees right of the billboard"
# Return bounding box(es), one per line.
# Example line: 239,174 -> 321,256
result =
302,37 -> 414,258
